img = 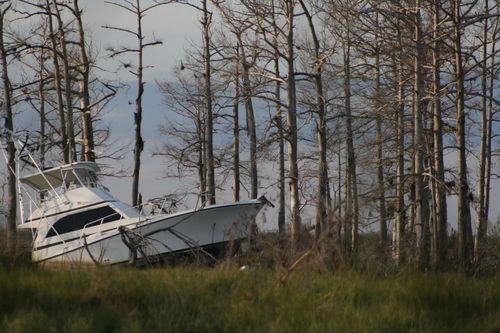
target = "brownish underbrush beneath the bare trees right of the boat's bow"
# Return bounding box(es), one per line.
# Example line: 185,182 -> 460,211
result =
231,228 -> 500,277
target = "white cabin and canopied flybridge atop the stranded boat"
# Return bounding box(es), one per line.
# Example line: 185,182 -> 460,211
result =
18,162 -> 140,238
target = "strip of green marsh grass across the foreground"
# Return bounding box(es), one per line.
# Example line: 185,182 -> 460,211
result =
0,266 -> 500,332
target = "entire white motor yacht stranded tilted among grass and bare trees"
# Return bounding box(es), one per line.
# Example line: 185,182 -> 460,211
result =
18,162 -> 268,268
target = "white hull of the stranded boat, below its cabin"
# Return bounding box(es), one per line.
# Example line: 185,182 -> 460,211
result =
33,200 -> 264,268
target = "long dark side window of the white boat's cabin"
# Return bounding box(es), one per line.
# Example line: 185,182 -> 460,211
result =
46,206 -> 122,237
